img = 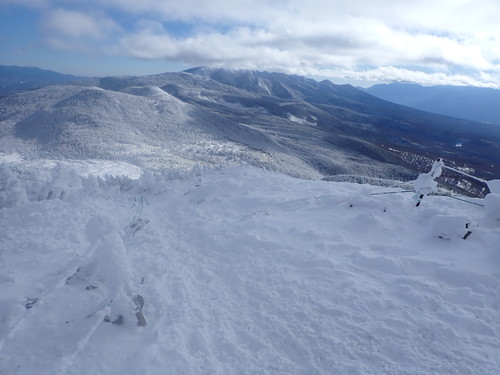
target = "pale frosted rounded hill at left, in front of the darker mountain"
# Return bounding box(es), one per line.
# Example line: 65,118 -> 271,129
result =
0,86 -> 314,175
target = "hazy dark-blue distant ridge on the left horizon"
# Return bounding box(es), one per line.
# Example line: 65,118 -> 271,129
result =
0,65 -> 83,94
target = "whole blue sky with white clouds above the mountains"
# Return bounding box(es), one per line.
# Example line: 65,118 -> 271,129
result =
0,0 -> 500,88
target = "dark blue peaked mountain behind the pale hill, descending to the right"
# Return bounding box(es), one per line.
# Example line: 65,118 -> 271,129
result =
101,68 -> 500,182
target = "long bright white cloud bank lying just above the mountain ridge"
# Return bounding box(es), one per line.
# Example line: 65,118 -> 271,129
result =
114,17 -> 498,86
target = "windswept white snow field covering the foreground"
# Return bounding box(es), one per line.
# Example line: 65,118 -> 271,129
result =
0,164 -> 500,375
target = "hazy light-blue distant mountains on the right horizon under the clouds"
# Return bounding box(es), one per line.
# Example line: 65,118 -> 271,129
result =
364,83 -> 500,125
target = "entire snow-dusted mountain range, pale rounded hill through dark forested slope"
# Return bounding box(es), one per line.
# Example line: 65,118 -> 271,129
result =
0,68 -> 500,195
